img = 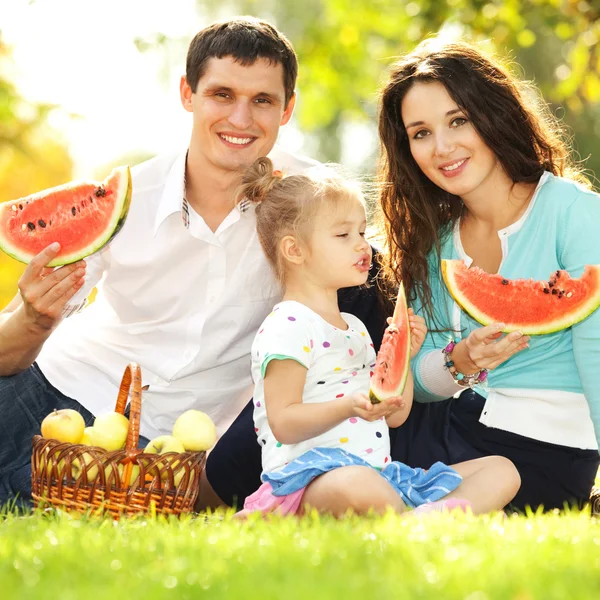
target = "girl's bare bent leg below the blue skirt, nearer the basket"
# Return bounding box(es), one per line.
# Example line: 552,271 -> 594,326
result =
300,466 -> 406,517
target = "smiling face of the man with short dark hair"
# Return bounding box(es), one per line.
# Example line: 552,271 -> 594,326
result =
180,56 -> 295,171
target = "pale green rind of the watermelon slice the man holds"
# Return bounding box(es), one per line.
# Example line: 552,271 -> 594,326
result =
0,166 -> 132,267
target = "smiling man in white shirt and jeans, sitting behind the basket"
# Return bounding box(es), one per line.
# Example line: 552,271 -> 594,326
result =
0,18 -> 386,507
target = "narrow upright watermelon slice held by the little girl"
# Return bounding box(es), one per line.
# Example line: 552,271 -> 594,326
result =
369,283 -> 410,404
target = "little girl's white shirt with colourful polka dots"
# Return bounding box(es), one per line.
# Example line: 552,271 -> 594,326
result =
252,301 -> 390,472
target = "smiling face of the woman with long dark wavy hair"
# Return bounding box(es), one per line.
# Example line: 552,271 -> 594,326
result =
402,82 -> 502,199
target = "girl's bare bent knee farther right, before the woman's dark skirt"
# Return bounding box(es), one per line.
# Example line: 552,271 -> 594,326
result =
444,456 -> 521,515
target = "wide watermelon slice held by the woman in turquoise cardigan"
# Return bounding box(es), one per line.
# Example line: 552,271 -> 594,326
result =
442,260 -> 600,335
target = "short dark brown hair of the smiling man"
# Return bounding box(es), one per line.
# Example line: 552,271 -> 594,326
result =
186,17 -> 298,106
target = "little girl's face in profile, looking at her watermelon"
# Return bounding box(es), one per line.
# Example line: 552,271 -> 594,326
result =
304,199 -> 371,289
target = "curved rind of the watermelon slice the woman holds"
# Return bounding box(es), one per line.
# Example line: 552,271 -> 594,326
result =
441,260 -> 600,335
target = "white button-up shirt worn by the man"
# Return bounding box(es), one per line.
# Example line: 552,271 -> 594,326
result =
37,143 -> 318,438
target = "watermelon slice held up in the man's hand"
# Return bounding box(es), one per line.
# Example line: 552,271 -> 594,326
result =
0,167 -> 131,267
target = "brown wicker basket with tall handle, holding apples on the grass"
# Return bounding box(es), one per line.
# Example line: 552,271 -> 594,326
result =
31,363 -> 206,518
